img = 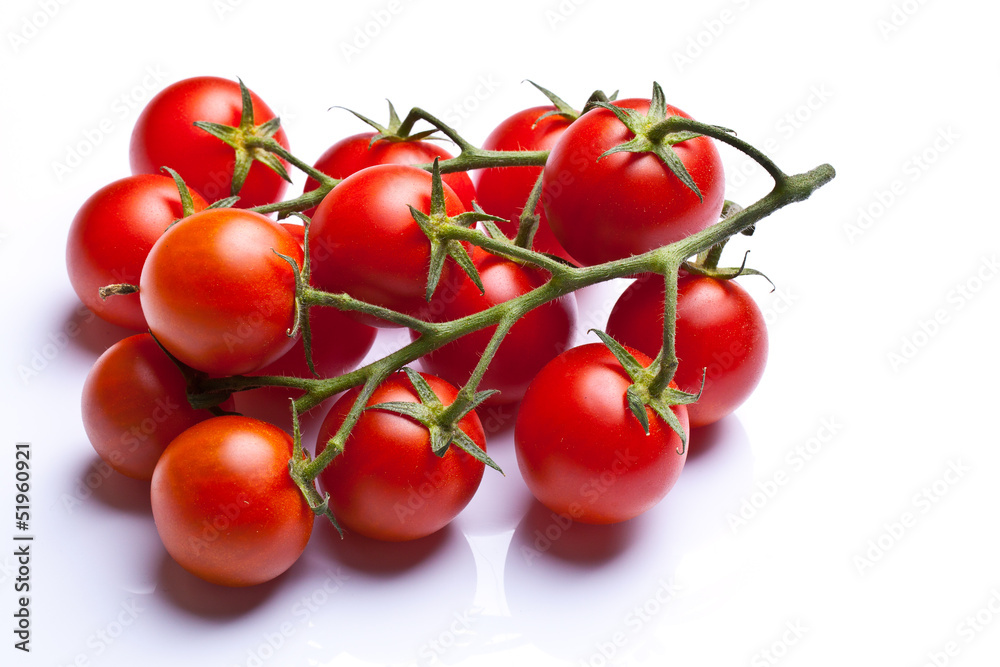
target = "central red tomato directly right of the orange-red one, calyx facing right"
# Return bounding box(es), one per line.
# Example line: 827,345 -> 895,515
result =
309,164 -> 465,327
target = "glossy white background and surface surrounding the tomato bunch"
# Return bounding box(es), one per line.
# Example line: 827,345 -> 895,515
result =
0,0 -> 1000,667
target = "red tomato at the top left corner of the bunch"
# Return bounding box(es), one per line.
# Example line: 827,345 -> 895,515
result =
129,76 -> 288,208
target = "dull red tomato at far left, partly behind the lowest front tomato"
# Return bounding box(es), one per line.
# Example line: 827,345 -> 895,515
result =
83,333 -> 233,480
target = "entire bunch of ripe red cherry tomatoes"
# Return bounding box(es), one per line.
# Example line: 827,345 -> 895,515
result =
66,77 -> 780,586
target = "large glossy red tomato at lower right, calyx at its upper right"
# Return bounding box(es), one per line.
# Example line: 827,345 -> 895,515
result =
514,343 -> 689,524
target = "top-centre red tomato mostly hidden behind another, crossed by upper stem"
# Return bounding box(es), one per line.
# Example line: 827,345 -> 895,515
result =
303,132 -> 476,217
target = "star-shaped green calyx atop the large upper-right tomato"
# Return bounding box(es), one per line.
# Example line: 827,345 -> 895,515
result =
593,83 -> 736,200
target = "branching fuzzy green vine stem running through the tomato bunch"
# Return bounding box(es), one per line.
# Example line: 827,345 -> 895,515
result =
194,100 -> 835,500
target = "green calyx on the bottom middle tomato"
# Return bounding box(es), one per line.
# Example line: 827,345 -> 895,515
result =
365,366 -> 503,474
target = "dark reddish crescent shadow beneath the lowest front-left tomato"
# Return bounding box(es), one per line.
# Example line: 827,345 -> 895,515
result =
157,551 -> 285,621
